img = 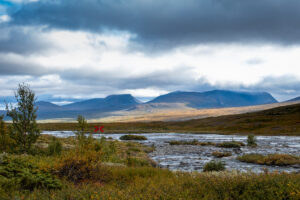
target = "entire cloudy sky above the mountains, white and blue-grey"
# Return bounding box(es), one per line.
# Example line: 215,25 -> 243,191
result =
0,0 -> 300,107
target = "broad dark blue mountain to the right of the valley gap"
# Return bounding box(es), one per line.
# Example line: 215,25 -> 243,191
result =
148,90 -> 277,108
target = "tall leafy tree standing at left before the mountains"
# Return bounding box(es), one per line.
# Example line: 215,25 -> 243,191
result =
6,84 -> 40,153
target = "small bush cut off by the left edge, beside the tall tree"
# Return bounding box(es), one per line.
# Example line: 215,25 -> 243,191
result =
0,116 -> 15,152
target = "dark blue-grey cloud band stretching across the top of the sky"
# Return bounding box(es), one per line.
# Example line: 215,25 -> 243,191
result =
12,0 -> 300,48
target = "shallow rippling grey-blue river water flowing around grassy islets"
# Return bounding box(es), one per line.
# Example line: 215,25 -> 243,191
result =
42,131 -> 300,173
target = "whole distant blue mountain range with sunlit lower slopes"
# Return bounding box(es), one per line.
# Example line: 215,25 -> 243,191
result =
1,90 -> 300,119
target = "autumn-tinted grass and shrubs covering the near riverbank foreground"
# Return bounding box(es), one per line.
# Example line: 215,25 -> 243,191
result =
0,135 -> 300,200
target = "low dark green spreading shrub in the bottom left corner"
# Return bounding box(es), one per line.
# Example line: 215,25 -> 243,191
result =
0,154 -> 61,191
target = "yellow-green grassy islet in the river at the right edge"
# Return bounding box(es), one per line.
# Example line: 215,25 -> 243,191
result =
237,154 -> 300,166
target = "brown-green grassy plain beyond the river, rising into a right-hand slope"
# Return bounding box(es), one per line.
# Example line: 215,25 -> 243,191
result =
39,104 -> 300,135
